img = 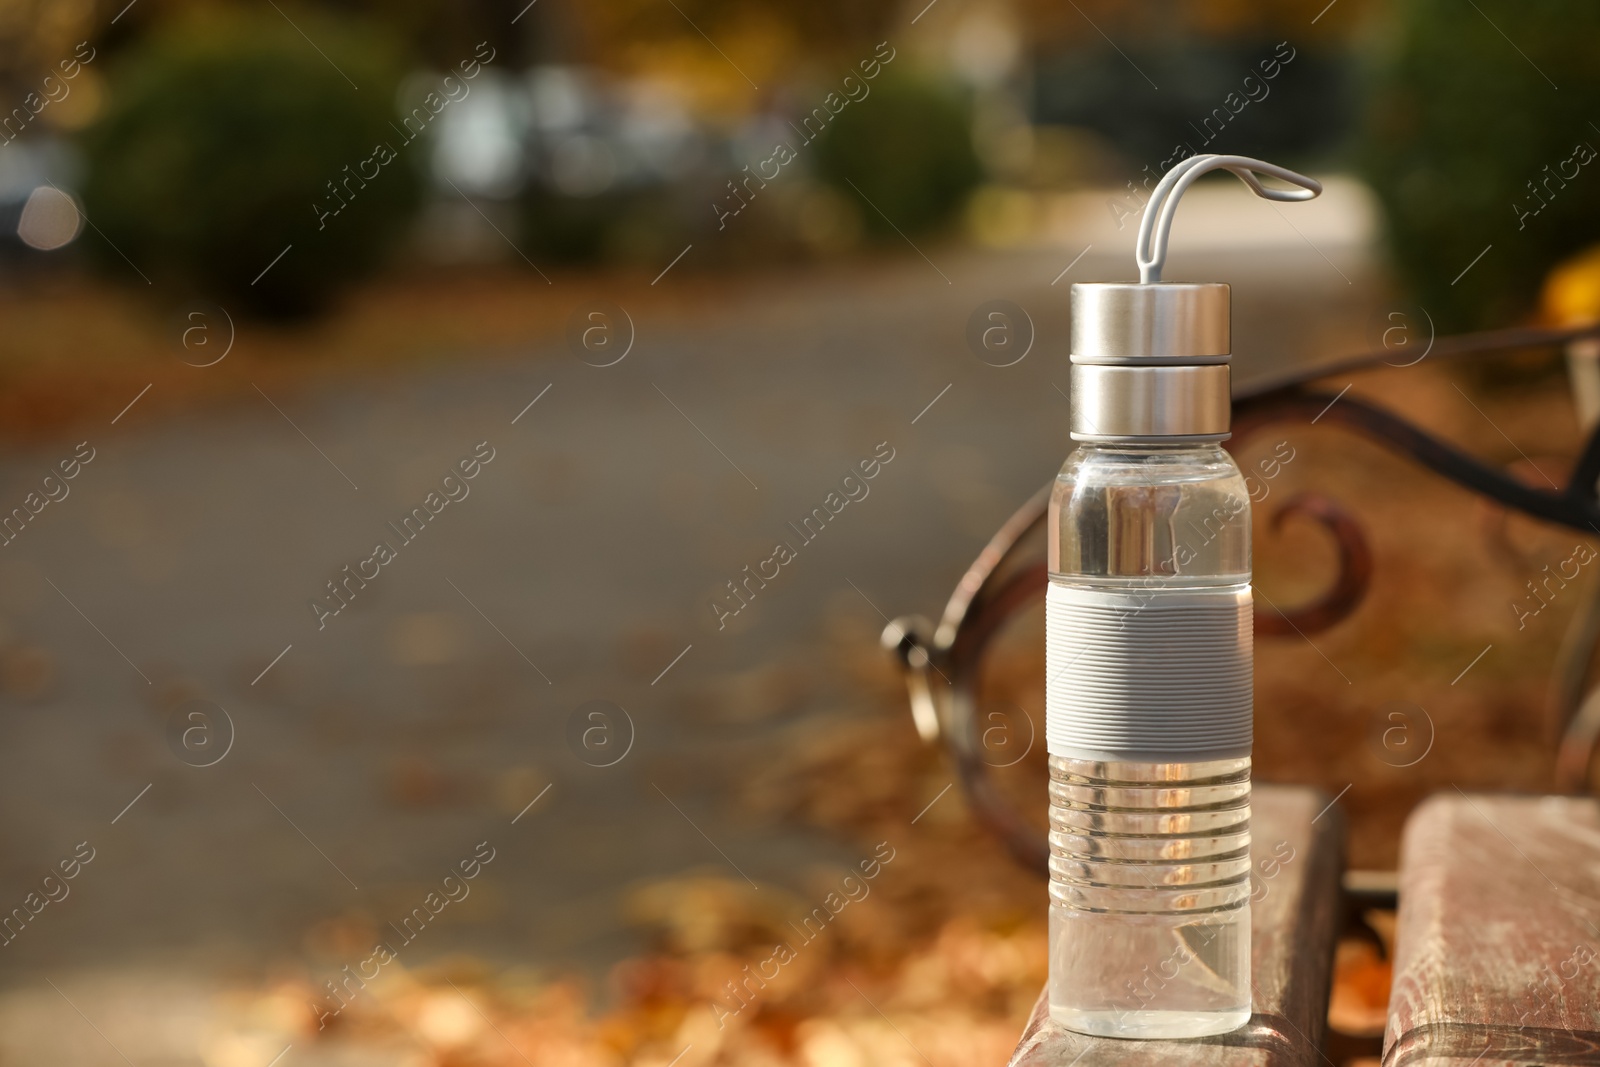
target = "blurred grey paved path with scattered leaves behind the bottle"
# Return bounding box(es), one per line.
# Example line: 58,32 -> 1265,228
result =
0,204 -> 1376,1055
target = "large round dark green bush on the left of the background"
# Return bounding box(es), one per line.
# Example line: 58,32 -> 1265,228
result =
83,10 -> 422,317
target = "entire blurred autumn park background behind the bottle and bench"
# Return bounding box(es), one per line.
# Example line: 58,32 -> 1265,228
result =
0,0 -> 1600,1067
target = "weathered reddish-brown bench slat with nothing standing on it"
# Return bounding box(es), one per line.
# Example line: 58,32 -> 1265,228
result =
1384,790 -> 1600,1067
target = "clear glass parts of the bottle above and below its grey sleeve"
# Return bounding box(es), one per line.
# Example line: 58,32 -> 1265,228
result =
1048,445 -> 1251,1038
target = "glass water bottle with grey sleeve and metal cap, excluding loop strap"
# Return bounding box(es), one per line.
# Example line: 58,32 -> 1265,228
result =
1045,283 -> 1253,1038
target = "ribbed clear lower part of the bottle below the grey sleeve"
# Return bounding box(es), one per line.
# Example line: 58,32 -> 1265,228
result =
1050,757 -> 1250,1038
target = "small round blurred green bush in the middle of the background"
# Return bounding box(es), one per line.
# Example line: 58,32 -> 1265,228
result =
814,72 -> 982,240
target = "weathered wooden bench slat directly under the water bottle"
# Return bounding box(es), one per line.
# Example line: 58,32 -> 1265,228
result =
1011,784 -> 1344,1067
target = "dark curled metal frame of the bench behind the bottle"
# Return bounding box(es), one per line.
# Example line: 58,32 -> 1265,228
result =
883,315 -> 1600,876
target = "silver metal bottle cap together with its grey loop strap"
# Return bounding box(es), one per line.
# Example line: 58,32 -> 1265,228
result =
1070,155 -> 1322,443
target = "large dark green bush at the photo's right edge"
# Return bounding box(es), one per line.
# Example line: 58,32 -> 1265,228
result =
1360,0 -> 1600,330
